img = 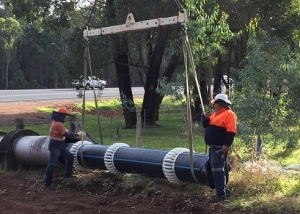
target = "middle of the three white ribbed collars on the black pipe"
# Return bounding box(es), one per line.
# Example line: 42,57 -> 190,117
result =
104,143 -> 129,174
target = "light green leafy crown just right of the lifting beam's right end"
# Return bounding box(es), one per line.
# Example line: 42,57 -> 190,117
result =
186,1 -> 239,64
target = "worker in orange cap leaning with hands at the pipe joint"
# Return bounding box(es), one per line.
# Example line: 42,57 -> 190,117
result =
44,107 -> 86,189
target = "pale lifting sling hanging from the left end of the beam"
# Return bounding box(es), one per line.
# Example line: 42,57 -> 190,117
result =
82,38 -> 103,145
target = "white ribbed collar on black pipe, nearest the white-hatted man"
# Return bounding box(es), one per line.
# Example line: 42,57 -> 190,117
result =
162,148 -> 189,184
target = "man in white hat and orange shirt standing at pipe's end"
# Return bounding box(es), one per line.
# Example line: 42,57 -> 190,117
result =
202,94 -> 237,202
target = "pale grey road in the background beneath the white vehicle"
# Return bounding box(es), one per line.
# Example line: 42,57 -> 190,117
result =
0,87 -> 144,103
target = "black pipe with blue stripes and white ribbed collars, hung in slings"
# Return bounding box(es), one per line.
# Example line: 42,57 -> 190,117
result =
70,142 -> 214,188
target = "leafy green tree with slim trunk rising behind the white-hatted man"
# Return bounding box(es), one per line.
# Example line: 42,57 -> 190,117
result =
186,0 -> 239,118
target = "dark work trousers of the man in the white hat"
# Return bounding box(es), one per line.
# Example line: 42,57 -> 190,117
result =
209,147 -> 227,197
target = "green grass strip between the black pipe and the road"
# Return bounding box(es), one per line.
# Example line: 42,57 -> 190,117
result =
1,99 -> 205,153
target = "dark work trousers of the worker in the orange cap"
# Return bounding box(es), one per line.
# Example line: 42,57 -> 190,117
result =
44,149 -> 74,187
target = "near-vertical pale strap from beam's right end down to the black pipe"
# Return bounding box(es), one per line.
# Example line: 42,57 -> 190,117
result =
183,25 -> 199,183
